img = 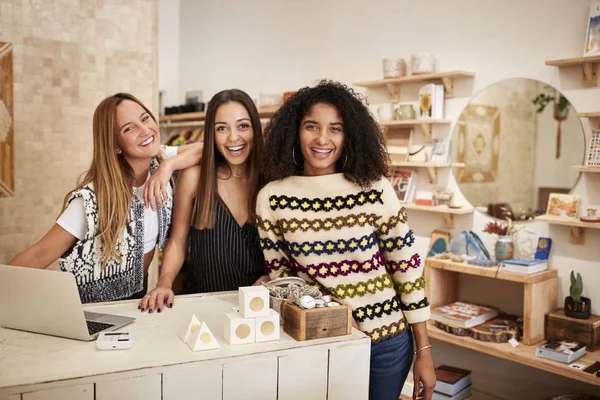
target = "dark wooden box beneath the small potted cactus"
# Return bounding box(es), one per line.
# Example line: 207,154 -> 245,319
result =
545,308 -> 600,351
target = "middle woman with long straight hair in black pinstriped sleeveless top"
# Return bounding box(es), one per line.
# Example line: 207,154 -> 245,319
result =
140,89 -> 264,312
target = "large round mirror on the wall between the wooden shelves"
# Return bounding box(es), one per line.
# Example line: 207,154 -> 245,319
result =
452,78 -> 585,221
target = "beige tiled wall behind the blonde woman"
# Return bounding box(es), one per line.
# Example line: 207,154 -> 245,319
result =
0,0 -> 158,264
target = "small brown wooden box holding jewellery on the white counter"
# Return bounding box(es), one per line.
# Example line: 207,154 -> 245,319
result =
281,301 -> 352,341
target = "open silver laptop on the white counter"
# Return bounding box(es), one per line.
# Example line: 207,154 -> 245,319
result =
0,265 -> 135,341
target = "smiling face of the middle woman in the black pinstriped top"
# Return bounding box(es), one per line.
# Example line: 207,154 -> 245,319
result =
215,101 -> 254,166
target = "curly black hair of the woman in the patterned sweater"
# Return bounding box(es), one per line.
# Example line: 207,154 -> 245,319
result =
261,80 -> 388,188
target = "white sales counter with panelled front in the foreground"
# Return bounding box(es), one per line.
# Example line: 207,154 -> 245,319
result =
0,292 -> 371,400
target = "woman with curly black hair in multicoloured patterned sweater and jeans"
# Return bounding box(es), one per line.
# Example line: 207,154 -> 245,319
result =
257,81 -> 436,400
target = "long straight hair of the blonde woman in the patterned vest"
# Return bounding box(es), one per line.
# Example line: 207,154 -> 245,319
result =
63,93 -> 162,268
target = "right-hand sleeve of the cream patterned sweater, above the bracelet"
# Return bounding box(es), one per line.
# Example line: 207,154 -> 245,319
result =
377,179 -> 430,324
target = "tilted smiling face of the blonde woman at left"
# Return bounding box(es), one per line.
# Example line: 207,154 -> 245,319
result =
115,100 -> 160,165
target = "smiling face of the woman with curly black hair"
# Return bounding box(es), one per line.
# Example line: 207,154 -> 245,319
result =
300,103 -> 344,176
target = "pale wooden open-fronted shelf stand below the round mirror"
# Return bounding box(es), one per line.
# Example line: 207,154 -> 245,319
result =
425,258 -> 558,345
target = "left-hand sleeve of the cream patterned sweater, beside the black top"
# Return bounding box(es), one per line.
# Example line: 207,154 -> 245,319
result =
256,186 -> 296,279
